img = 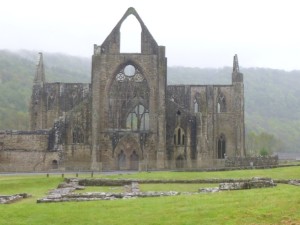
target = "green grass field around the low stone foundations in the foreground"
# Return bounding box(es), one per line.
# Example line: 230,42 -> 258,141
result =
0,167 -> 300,225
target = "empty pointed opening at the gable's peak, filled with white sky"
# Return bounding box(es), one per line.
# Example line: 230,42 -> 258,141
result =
120,15 -> 142,53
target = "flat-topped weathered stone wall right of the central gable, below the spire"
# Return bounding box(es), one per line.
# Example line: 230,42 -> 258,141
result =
166,80 -> 244,167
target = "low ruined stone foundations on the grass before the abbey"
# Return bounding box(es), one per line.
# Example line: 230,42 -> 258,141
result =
37,177 -> 286,203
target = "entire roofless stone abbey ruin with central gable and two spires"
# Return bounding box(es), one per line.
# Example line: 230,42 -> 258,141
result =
0,8 -> 245,171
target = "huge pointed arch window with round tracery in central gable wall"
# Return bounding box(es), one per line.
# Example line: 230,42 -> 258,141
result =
108,61 -> 150,130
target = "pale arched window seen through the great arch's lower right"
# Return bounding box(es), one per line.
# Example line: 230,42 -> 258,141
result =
126,104 -> 149,130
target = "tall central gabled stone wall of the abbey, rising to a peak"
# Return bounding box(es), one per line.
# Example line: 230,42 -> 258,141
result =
92,8 -> 166,170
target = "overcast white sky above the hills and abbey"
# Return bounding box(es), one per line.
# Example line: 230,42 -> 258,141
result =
0,0 -> 300,70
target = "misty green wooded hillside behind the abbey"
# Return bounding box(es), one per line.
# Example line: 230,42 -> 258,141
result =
0,50 -> 300,151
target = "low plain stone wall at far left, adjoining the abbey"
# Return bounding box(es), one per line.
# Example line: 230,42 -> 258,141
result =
0,130 -> 59,172
